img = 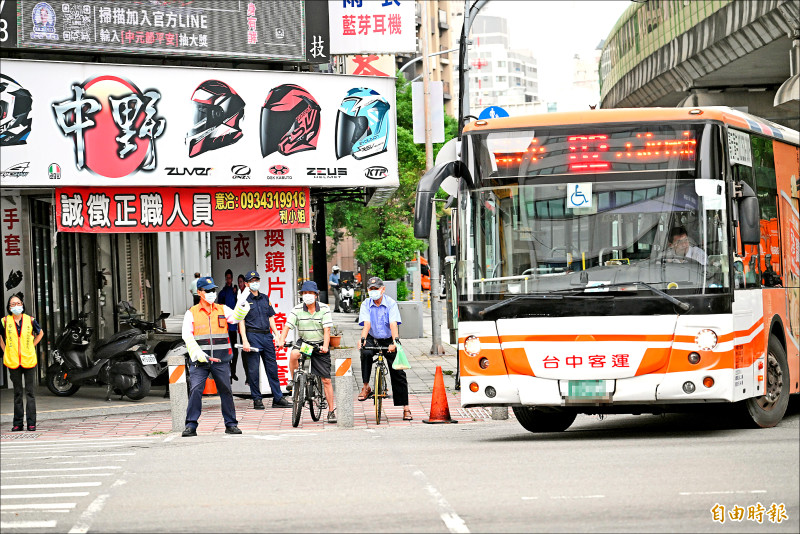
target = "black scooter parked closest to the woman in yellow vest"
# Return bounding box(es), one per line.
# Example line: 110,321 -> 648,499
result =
47,295 -> 169,400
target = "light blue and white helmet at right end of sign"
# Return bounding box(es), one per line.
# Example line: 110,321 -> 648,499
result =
336,87 -> 389,159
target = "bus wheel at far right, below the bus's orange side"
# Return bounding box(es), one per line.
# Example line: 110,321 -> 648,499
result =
742,336 -> 789,428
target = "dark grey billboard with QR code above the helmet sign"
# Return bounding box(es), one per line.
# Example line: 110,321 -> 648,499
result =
10,0 -> 329,63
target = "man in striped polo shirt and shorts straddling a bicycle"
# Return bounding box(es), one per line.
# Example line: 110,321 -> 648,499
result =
278,280 -> 336,423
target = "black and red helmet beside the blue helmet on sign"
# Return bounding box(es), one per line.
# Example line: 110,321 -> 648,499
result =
261,84 -> 321,157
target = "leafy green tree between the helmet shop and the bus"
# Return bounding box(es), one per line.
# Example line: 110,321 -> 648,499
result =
325,74 -> 458,299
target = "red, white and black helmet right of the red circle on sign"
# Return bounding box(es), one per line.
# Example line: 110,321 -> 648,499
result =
186,80 -> 244,158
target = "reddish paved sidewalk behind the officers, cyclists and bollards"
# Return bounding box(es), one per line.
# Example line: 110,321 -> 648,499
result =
0,302 -> 468,439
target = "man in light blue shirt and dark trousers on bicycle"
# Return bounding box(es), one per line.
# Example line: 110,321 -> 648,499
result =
358,276 -> 412,421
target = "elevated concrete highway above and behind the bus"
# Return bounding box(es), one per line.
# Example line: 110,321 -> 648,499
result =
600,0 -> 800,129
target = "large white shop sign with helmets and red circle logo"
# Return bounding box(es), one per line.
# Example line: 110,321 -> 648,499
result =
0,58 -> 398,188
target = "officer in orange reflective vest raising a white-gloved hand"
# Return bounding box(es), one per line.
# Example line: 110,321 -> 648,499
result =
181,276 -> 250,437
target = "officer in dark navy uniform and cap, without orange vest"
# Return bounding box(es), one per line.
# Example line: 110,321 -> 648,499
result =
239,271 -> 292,410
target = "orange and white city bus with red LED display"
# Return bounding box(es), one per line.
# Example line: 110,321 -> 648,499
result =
415,107 -> 800,432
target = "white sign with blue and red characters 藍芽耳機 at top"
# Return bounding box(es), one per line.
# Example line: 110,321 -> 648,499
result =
328,0 -> 417,54
